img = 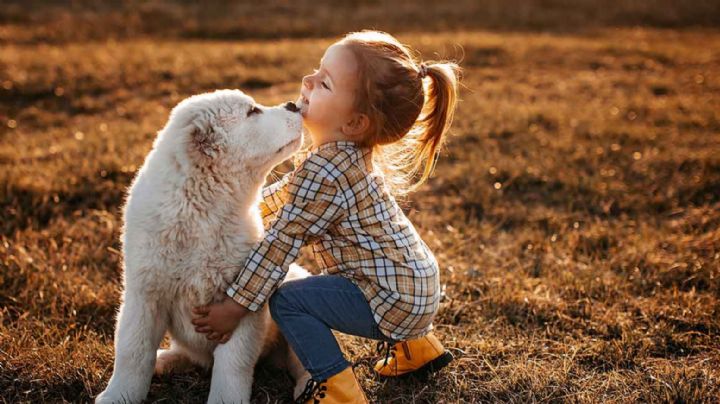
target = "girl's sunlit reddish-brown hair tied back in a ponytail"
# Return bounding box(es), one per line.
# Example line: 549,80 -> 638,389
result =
339,30 -> 461,197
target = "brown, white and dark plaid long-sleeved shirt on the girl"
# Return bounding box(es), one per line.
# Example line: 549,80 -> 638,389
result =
227,140 -> 440,340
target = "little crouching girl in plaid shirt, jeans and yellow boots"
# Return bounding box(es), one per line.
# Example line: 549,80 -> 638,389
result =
193,30 -> 460,402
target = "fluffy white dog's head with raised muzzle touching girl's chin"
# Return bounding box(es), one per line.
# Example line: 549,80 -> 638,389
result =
170,90 -> 303,178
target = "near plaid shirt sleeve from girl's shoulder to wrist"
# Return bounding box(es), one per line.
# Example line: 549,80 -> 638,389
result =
226,165 -> 347,311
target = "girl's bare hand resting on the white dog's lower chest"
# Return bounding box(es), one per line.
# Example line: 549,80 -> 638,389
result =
192,296 -> 250,343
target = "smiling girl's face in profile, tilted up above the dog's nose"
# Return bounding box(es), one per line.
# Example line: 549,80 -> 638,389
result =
298,44 -> 357,146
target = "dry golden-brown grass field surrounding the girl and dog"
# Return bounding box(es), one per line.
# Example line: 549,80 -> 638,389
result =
0,0 -> 720,403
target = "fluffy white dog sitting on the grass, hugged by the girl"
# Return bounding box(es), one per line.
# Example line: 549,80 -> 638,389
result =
96,90 -> 307,403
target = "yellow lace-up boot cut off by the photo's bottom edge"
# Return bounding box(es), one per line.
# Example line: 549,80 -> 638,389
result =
295,366 -> 368,404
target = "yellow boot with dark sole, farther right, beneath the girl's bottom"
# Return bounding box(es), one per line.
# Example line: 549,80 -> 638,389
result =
375,334 -> 453,377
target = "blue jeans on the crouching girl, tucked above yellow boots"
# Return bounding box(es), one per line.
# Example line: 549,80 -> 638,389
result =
270,275 -> 395,380
